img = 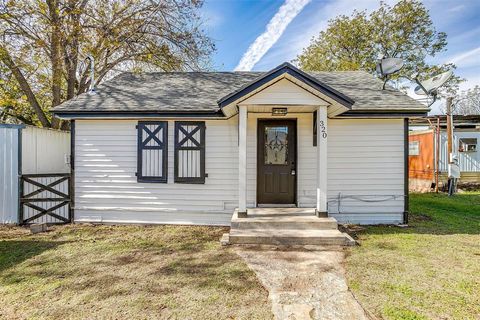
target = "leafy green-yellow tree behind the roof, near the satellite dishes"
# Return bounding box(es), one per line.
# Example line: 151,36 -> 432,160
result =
296,0 -> 460,91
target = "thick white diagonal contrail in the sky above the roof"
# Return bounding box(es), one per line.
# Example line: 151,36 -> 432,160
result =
235,0 -> 311,71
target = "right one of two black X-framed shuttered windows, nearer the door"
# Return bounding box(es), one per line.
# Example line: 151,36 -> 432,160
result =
175,121 -> 205,183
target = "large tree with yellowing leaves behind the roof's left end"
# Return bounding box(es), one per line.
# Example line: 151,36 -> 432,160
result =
0,0 -> 214,128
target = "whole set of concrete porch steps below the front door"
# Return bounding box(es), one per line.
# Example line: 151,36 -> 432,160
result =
222,208 -> 355,245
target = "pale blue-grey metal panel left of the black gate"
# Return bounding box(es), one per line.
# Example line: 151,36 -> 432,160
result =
0,126 -> 21,223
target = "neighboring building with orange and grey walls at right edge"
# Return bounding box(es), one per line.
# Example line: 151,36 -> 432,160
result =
409,115 -> 480,191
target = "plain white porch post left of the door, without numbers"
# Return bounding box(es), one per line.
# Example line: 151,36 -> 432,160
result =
238,106 -> 247,215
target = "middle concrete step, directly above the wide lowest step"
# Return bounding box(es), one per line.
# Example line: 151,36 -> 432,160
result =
231,216 -> 338,230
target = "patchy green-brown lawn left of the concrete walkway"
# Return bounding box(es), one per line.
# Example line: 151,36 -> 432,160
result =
0,225 -> 272,319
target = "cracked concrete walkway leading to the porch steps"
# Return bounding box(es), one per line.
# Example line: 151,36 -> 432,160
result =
236,246 -> 368,320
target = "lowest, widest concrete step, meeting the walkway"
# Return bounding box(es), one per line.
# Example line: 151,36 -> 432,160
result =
228,228 -> 355,246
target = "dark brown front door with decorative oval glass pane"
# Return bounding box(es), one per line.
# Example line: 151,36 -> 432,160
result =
257,120 -> 297,204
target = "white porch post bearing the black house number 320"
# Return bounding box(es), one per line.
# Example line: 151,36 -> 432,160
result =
315,106 -> 328,216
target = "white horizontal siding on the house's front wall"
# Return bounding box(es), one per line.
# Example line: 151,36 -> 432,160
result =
75,117 -> 404,225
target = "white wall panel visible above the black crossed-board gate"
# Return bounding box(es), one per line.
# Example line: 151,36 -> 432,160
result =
22,126 -> 70,174
